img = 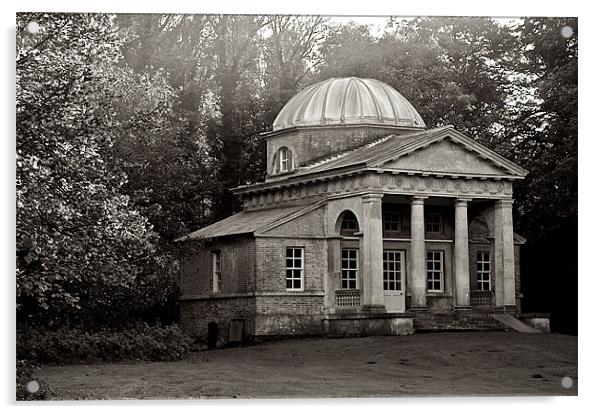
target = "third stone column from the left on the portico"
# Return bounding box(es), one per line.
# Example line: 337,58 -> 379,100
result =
454,198 -> 470,309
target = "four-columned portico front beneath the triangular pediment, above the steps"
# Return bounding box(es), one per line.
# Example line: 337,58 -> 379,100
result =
359,193 -> 516,312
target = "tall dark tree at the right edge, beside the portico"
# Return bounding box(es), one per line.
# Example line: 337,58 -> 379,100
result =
509,18 -> 578,333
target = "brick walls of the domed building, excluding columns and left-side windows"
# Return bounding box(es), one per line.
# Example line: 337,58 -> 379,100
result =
181,197 -> 520,344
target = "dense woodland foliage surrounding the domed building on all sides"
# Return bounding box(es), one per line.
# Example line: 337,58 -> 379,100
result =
16,13 -> 577,336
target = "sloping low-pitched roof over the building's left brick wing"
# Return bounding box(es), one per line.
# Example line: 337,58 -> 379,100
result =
176,206 -> 307,241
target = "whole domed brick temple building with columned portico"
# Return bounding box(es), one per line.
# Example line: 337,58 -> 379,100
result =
179,77 -> 527,341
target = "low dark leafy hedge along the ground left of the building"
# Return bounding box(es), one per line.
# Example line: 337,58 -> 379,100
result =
17,324 -> 194,362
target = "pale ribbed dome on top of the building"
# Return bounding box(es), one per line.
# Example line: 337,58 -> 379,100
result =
272,77 -> 426,131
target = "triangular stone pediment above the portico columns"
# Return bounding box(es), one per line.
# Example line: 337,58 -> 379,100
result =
379,137 -> 513,176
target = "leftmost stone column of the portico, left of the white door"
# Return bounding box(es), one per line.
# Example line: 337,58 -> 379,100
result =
362,194 -> 385,312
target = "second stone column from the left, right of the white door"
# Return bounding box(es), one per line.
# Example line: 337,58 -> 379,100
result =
410,196 -> 426,309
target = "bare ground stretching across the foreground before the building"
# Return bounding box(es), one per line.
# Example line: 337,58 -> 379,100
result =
39,332 -> 577,399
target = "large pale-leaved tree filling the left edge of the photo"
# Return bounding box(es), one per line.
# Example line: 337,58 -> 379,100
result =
16,13 -> 176,322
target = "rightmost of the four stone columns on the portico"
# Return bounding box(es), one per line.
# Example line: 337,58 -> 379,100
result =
494,200 -> 516,309
